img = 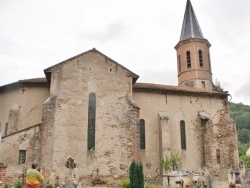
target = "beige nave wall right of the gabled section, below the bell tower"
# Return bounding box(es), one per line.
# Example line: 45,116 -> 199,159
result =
133,89 -> 238,181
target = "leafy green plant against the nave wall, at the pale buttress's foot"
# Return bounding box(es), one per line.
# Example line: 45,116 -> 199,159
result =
161,151 -> 181,171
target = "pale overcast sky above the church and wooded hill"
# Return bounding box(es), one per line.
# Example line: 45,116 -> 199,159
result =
0,0 -> 250,105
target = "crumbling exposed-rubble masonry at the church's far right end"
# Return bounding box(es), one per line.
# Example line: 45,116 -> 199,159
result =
209,104 -> 239,179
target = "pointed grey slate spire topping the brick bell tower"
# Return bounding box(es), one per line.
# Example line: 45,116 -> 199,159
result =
180,0 -> 204,41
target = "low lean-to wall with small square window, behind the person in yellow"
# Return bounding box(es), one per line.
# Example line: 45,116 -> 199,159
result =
0,124 -> 41,184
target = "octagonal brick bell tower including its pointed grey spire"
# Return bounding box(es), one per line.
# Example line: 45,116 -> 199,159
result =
175,0 -> 213,89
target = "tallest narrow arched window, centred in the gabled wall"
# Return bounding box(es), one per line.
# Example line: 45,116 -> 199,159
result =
88,93 -> 96,150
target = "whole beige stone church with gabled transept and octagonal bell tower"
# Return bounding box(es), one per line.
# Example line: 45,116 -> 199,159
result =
0,0 -> 239,185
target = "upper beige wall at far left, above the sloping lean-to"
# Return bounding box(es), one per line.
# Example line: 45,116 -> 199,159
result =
0,85 -> 49,136
